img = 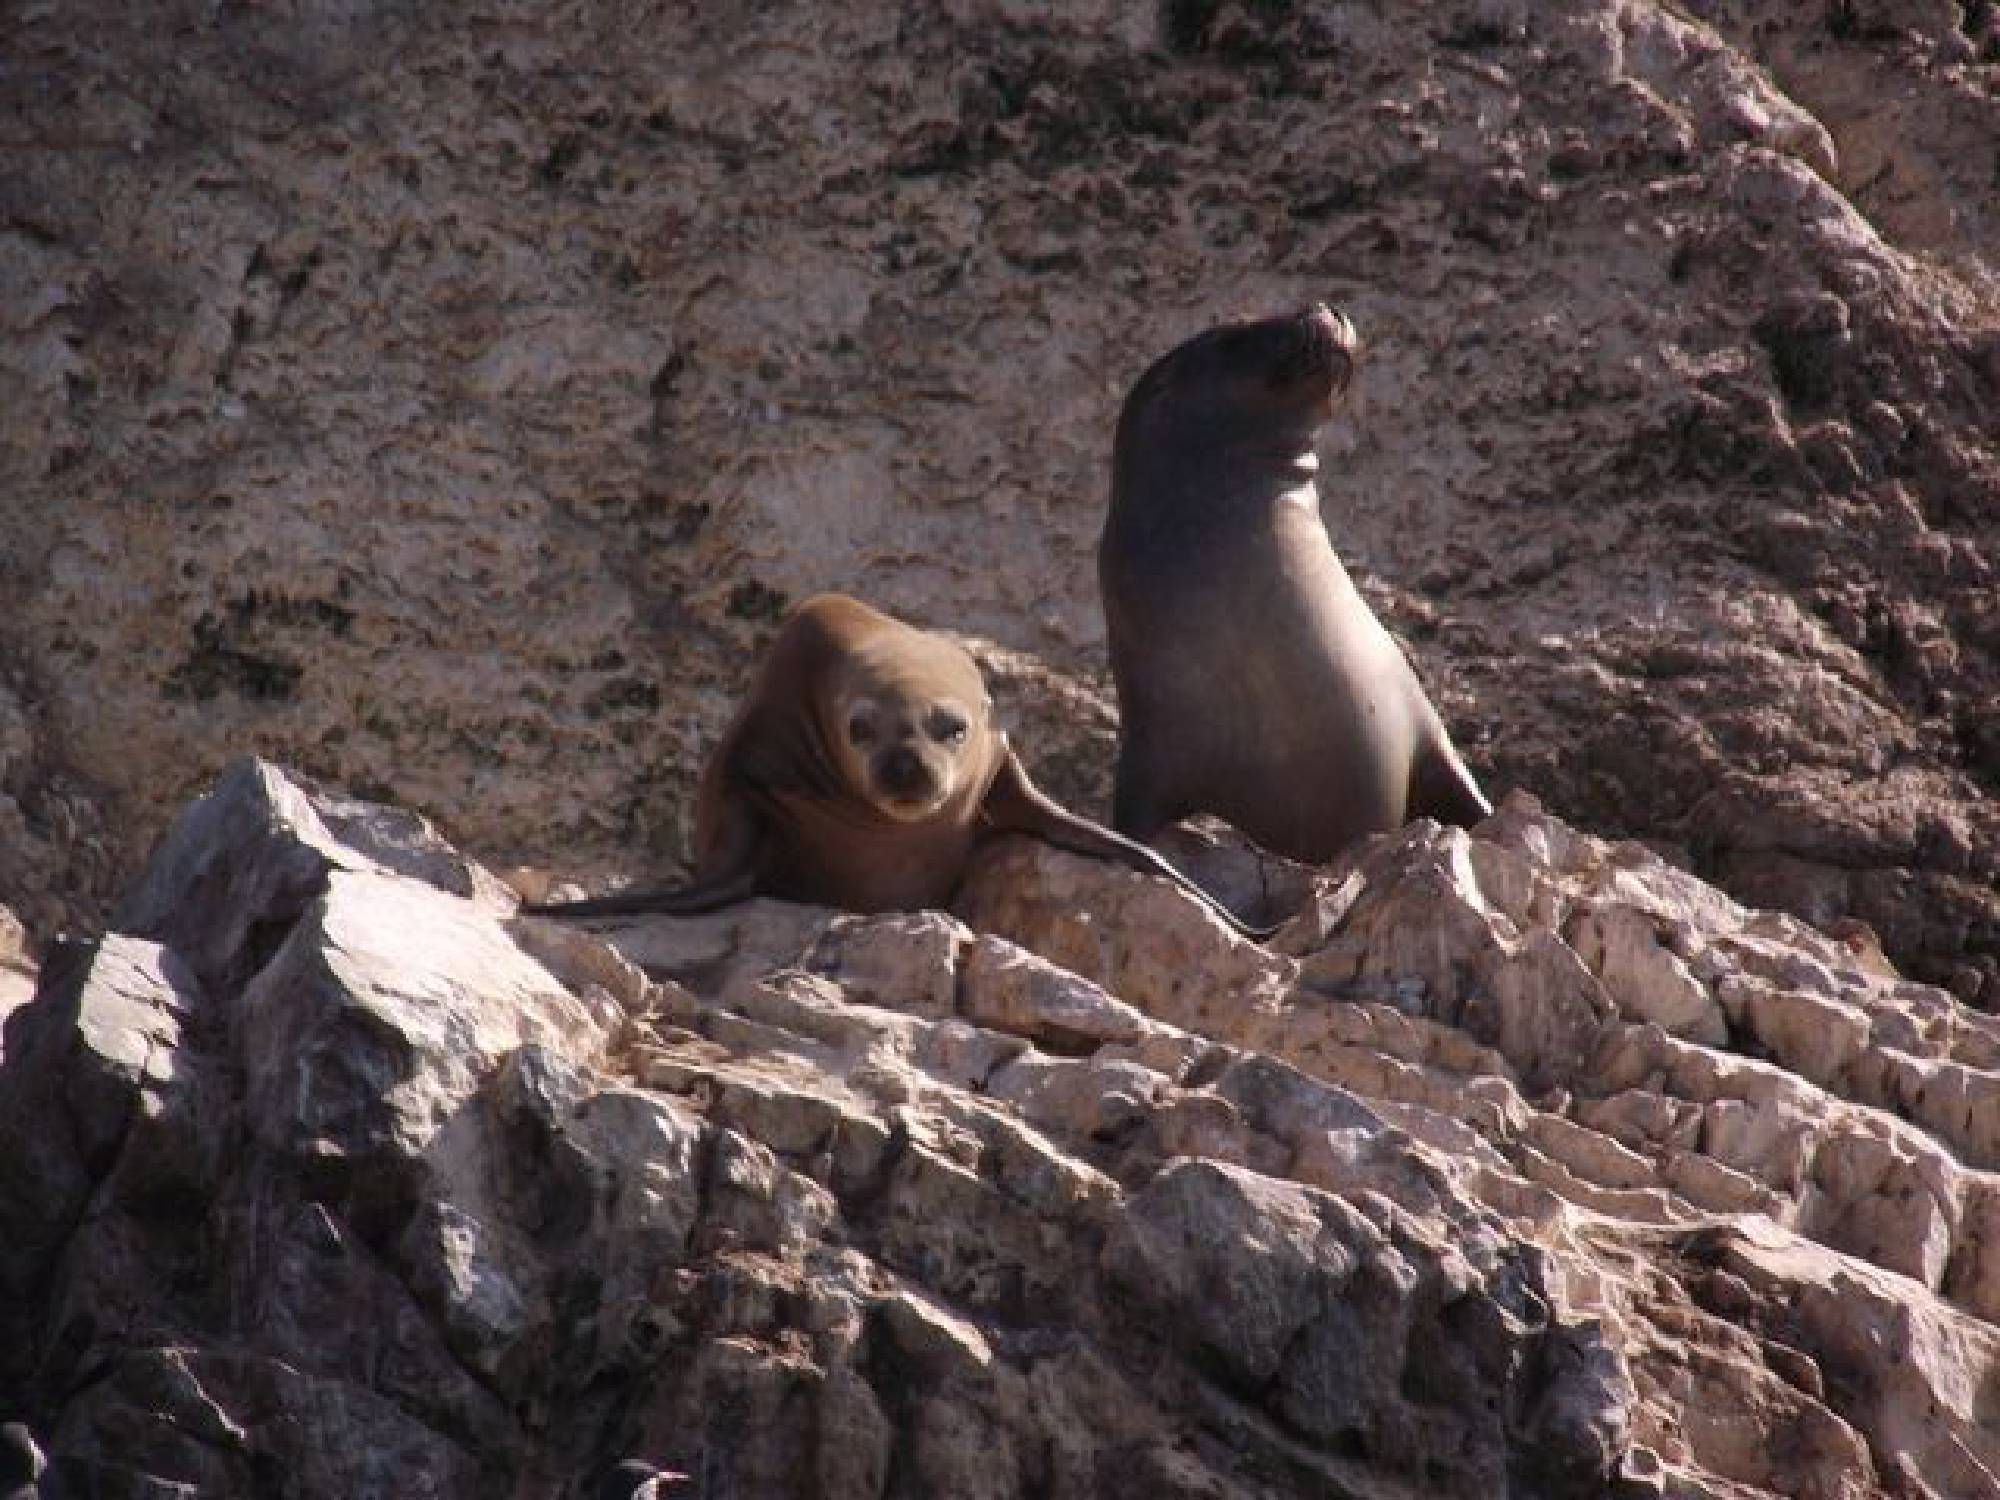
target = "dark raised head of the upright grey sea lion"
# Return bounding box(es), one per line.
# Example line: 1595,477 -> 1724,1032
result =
1118,302 -> 1360,470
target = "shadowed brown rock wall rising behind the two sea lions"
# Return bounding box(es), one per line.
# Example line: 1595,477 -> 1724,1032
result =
0,0 -> 2000,1008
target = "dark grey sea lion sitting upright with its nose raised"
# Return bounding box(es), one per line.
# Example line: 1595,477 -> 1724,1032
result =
1098,306 -> 1492,862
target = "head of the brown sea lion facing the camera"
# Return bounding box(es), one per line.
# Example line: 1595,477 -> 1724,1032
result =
822,630 -> 996,822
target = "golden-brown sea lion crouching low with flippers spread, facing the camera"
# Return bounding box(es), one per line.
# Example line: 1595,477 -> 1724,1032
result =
524,594 -> 1268,936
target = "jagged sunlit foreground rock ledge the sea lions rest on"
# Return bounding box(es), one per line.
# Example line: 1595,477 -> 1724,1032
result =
0,762 -> 2000,1500
